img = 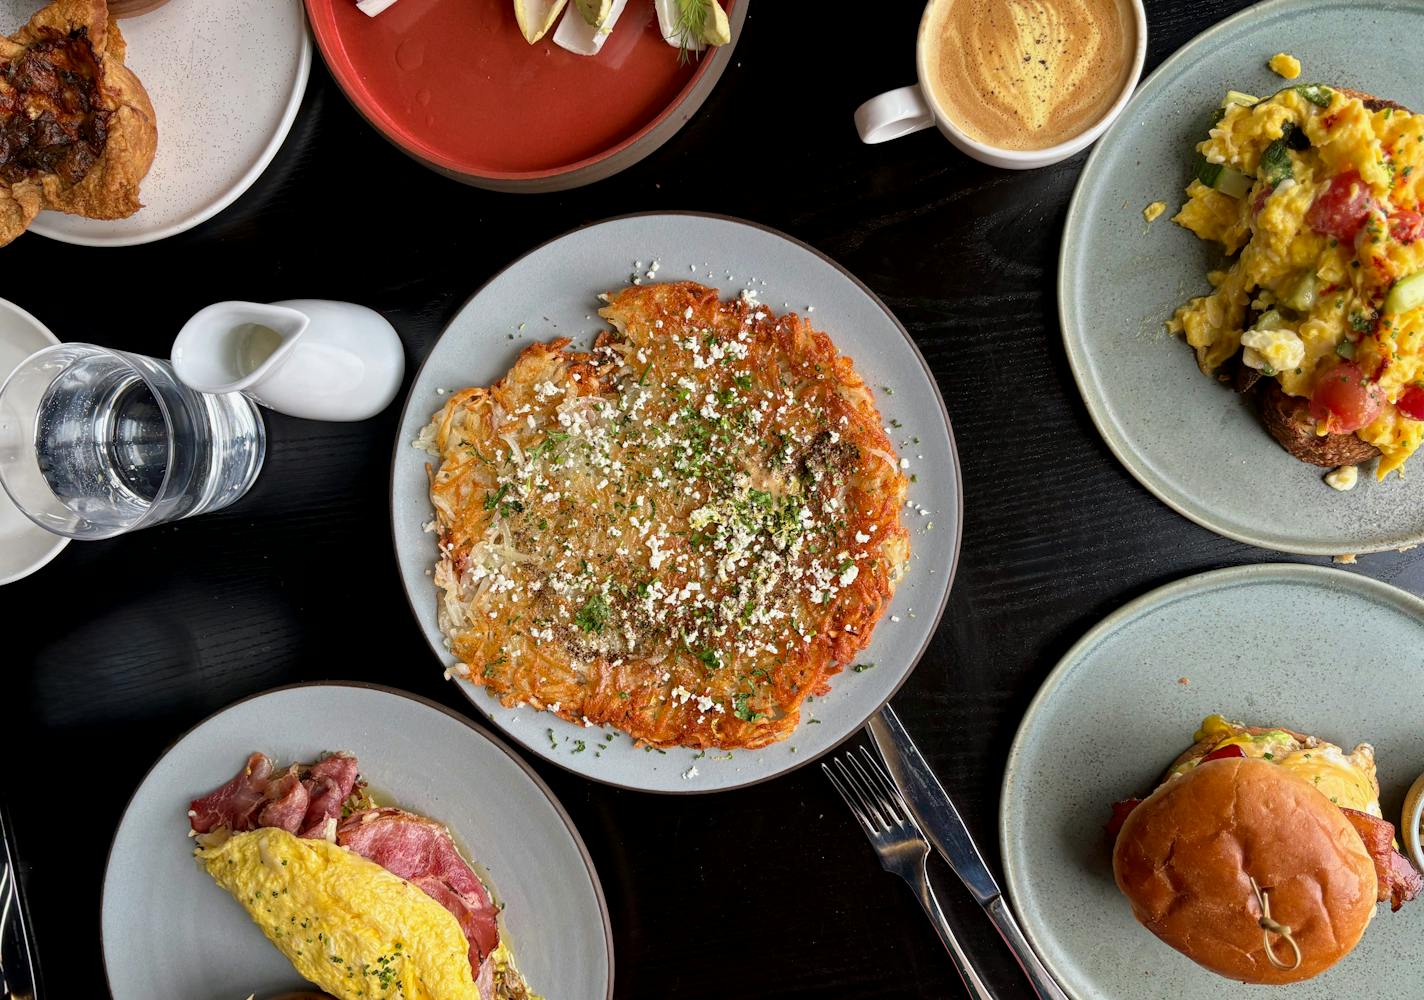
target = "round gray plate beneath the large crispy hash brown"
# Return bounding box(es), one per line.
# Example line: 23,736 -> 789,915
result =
392,214 -> 961,792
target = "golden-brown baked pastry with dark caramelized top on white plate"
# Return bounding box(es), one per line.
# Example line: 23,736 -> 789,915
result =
0,0 -> 158,246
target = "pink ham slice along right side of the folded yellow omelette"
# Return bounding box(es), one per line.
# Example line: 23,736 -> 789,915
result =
336,808 -> 500,977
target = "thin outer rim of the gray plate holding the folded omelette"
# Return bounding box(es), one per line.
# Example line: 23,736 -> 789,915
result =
98,679 -> 617,1000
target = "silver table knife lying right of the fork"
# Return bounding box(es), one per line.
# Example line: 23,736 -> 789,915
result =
866,705 -> 1068,1000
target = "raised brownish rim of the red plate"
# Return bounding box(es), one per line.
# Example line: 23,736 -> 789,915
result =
302,0 -> 750,194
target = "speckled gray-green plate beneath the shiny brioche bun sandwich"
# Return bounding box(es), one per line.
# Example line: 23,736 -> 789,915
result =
1000,566 -> 1424,1000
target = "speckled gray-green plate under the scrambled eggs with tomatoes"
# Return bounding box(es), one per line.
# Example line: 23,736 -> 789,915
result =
1058,0 -> 1424,556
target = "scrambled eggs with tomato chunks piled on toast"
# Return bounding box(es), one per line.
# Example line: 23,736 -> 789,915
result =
1168,84 -> 1424,479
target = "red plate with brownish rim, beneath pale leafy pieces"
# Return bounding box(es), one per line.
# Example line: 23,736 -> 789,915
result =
306,0 -> 749,191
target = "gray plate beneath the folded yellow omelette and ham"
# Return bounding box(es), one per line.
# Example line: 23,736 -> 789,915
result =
103,684 -> 614,1000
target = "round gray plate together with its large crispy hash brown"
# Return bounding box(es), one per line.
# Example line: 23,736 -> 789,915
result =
392,214 -> 961,793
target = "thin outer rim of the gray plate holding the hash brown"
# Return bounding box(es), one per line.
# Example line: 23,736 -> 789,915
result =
389,211 -> 964,796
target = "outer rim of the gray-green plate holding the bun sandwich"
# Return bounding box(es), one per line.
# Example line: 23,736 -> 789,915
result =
997,564 -> 1424,1000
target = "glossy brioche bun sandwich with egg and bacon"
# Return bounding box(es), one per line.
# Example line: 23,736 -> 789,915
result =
1108,715 -> 1424,984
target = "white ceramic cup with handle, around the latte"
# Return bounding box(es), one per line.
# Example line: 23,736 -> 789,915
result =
856,0 -> 1148,170
